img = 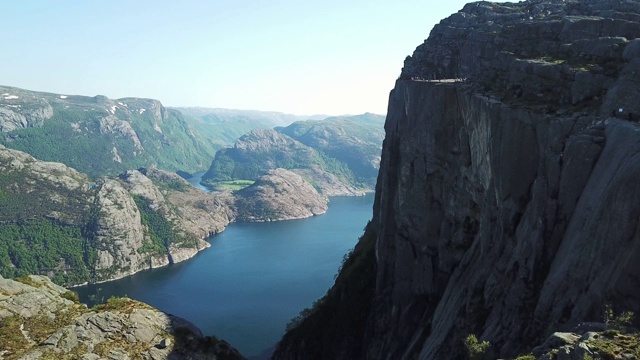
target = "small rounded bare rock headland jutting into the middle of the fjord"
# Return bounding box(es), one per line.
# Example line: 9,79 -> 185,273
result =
234,169 -> 329,221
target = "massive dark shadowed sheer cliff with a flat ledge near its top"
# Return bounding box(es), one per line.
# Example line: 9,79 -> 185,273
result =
274,0 -> 640,359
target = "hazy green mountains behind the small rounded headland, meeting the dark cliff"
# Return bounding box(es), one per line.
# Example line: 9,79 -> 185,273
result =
202,114 -> 384,196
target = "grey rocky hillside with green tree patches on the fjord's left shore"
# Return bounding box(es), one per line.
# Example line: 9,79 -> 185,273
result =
0,145 -> 231,284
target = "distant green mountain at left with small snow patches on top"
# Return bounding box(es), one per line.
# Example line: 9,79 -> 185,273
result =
0,86 -> 221,177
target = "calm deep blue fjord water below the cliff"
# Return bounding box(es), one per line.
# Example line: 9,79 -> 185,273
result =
75,177 -> 373,356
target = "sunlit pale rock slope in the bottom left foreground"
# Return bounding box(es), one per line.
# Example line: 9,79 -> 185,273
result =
0,276 -> 243,360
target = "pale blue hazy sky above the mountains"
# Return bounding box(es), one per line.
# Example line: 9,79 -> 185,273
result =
0,0 -> 490,115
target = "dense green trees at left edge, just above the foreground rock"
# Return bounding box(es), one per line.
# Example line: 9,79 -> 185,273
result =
0,220 -> 90,284
